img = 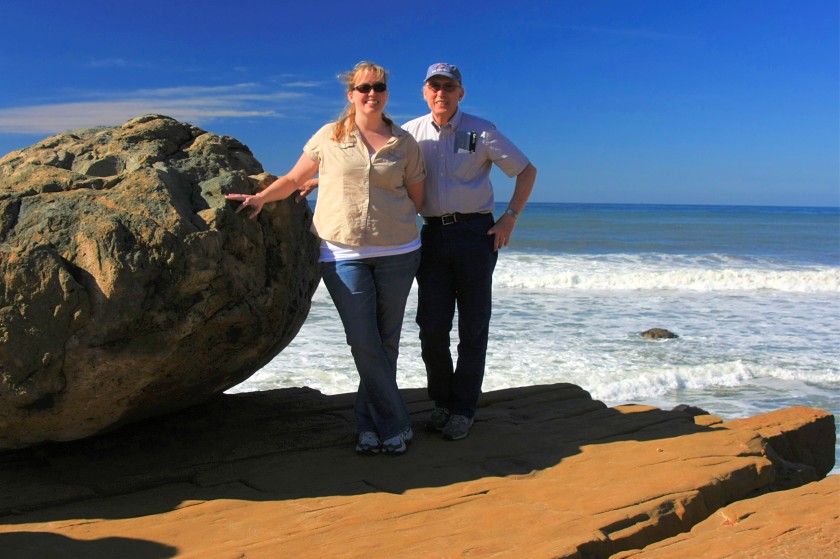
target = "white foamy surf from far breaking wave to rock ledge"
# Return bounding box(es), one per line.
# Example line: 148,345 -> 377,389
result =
230,253 -> 840,472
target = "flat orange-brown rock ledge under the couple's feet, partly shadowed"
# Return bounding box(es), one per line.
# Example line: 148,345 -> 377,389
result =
0,384 -> 837,559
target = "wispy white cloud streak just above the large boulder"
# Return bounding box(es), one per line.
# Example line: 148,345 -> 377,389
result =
0,83 -> 306,134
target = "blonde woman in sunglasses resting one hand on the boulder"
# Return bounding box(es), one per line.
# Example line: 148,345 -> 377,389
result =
227,62 -> 426,454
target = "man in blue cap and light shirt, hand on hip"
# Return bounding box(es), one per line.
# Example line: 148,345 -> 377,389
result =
403,63 -> 537,441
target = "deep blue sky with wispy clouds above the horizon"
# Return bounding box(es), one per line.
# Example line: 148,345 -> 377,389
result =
0,0 -> 840,206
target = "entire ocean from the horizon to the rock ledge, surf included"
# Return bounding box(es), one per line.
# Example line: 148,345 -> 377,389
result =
229,203 -> 840,473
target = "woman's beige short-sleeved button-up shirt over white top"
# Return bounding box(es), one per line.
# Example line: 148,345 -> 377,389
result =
303,123 -> 426,246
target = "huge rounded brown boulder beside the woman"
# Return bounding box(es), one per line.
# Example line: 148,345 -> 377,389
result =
0,115 -> 318,448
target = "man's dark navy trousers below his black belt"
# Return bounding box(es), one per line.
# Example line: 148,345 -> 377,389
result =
417,214 -> 498,417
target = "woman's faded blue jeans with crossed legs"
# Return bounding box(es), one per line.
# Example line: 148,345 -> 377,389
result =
321,250 -> 420,439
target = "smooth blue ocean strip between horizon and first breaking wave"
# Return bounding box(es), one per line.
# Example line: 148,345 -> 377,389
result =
508,203 -> 840,266
